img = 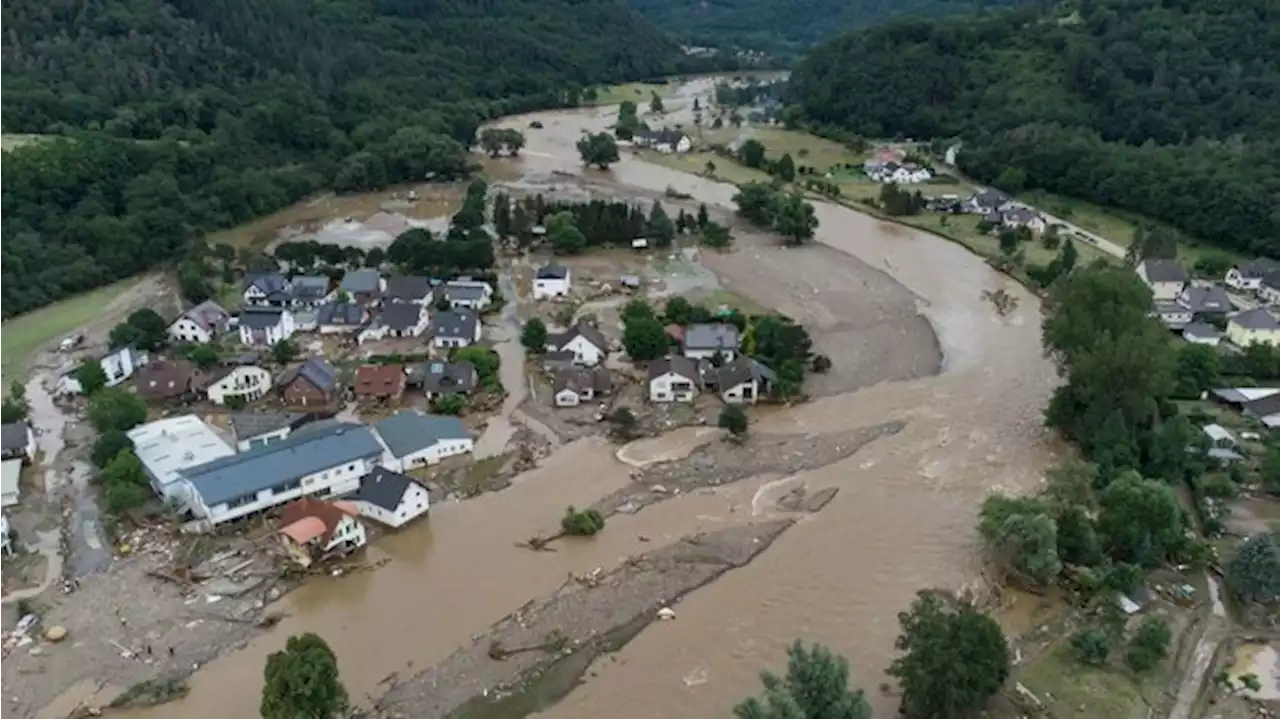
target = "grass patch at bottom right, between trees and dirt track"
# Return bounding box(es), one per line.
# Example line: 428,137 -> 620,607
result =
1018,642 -> 1169,719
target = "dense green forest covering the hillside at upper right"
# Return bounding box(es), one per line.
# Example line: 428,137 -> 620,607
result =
791,0 -> 1280,257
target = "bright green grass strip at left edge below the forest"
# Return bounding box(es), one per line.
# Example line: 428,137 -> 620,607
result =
0,279 -> 137,381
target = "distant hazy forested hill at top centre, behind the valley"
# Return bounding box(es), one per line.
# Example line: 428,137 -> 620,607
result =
627,0 -> 1025,59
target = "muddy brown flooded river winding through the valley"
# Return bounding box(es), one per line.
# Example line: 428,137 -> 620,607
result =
110,75 -> 1055,719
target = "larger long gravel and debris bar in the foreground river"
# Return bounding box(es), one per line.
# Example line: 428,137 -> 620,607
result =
370,519 -> 794,719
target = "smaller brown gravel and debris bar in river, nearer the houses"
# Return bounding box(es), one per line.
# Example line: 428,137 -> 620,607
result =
604,422 -> 906,516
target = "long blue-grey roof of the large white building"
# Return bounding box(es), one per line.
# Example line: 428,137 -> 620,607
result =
182,422 -> 383,507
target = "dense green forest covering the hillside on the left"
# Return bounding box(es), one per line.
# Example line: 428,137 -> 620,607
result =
0,0 -> 710,319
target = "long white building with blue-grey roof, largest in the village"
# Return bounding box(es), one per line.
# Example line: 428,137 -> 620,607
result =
177,422 -> 383,528
